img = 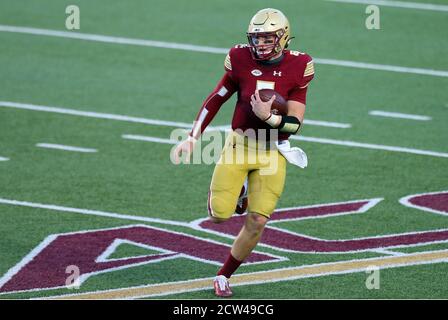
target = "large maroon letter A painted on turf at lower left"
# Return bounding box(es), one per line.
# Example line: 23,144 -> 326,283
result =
0,226 -> 279,292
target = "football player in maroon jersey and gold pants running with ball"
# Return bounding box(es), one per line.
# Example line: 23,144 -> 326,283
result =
174,8 -> 314,297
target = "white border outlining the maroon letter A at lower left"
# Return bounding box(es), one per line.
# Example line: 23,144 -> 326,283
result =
0,224 -> 289,296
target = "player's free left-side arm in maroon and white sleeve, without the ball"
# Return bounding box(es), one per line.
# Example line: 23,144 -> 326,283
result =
174,52 -> 238,164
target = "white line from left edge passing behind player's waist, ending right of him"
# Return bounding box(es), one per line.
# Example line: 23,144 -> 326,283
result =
0,101 -> 351,129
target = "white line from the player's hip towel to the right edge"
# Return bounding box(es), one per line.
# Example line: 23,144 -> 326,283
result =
289,136 -> 448,158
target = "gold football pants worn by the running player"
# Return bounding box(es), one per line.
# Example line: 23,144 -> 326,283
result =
208,131 -> 286,219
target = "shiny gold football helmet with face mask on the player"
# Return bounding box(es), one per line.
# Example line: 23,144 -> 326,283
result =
247,8 -> 291,60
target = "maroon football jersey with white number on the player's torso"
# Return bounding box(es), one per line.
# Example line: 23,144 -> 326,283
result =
224,44 -> 314,140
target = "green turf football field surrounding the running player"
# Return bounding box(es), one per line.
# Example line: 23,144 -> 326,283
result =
0,0 -> 448,299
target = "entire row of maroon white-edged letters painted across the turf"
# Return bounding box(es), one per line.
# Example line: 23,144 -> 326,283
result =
0,191 -> 448,292
